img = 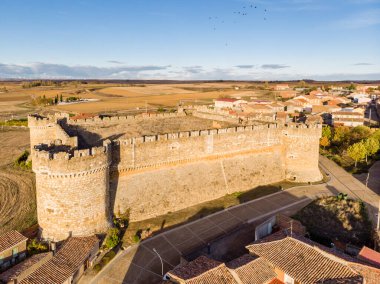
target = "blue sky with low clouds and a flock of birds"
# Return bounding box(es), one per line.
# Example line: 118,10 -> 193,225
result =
0,0 -> 380,80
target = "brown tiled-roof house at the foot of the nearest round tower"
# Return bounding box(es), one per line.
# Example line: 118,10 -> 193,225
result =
0,236 -> 99,284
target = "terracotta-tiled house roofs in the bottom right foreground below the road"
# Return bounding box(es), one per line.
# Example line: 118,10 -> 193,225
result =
165,230 -> 380,284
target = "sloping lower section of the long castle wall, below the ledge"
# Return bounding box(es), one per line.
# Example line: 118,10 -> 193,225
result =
111,146 -> 285,221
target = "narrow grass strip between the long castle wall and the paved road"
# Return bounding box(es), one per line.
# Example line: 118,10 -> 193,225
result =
123,181 -> 302,246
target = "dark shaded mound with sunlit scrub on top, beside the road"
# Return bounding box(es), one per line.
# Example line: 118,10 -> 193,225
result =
294,195 -> 372,247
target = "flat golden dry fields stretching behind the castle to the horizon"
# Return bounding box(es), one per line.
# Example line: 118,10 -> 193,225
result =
0,82 -> 272,117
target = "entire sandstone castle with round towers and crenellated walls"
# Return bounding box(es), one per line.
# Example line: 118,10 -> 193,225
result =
28,112 -> 322,241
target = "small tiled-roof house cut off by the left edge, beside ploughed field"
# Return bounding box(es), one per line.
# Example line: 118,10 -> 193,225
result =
0,230 -> 28,271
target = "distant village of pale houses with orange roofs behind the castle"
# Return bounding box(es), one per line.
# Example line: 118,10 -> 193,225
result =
212,84 -> 380,127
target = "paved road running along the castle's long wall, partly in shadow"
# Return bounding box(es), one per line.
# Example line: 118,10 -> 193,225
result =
81,157 -> 378,284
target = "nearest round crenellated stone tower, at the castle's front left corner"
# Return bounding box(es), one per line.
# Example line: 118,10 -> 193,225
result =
32,141 -> 111,241
